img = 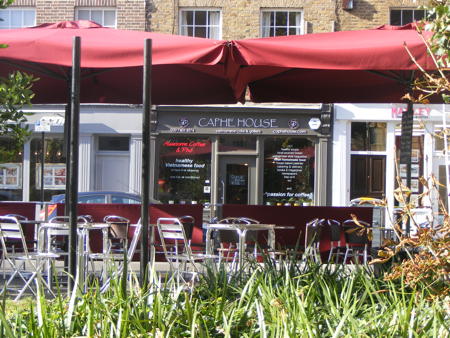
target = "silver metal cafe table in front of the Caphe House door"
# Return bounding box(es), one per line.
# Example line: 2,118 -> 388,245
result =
205,223 -> 275,268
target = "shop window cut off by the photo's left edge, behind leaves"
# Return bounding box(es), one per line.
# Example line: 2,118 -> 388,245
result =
0,138 -> 23,201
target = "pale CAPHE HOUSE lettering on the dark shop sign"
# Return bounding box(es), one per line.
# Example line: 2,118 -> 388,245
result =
198,117 -> 278,128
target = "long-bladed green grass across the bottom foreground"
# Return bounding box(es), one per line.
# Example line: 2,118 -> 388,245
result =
0,263 -> 450,337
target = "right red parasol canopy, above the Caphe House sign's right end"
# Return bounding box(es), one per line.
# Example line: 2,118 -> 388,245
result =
232,24 -> 435,103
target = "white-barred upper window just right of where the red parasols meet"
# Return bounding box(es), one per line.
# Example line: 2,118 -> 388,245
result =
261,10 -> 303,37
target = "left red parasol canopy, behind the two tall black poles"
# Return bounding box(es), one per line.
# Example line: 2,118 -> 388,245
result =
0,21 -> 236,104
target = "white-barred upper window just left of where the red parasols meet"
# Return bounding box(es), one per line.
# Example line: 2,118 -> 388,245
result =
180,9 -> 222,39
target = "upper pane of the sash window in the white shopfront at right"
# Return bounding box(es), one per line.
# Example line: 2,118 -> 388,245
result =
351,122 -> 386,151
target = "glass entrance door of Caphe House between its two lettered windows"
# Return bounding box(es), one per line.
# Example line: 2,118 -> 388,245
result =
218,155 -> 257,204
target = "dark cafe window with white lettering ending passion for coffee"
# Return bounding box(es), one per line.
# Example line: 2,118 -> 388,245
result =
264,137 -> 315,205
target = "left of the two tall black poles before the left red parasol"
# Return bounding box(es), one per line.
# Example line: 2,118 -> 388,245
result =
66,36 -> 81,294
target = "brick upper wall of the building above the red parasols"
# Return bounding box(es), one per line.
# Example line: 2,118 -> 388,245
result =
7,0 -> 427,35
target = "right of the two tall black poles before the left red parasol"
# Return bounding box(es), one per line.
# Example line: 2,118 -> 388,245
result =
140,39 -> 153,286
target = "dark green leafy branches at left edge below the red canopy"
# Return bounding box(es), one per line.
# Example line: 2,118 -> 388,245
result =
0,0 -> 36,156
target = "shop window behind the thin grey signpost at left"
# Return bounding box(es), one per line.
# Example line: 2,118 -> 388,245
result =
30,138 -> 66,201
